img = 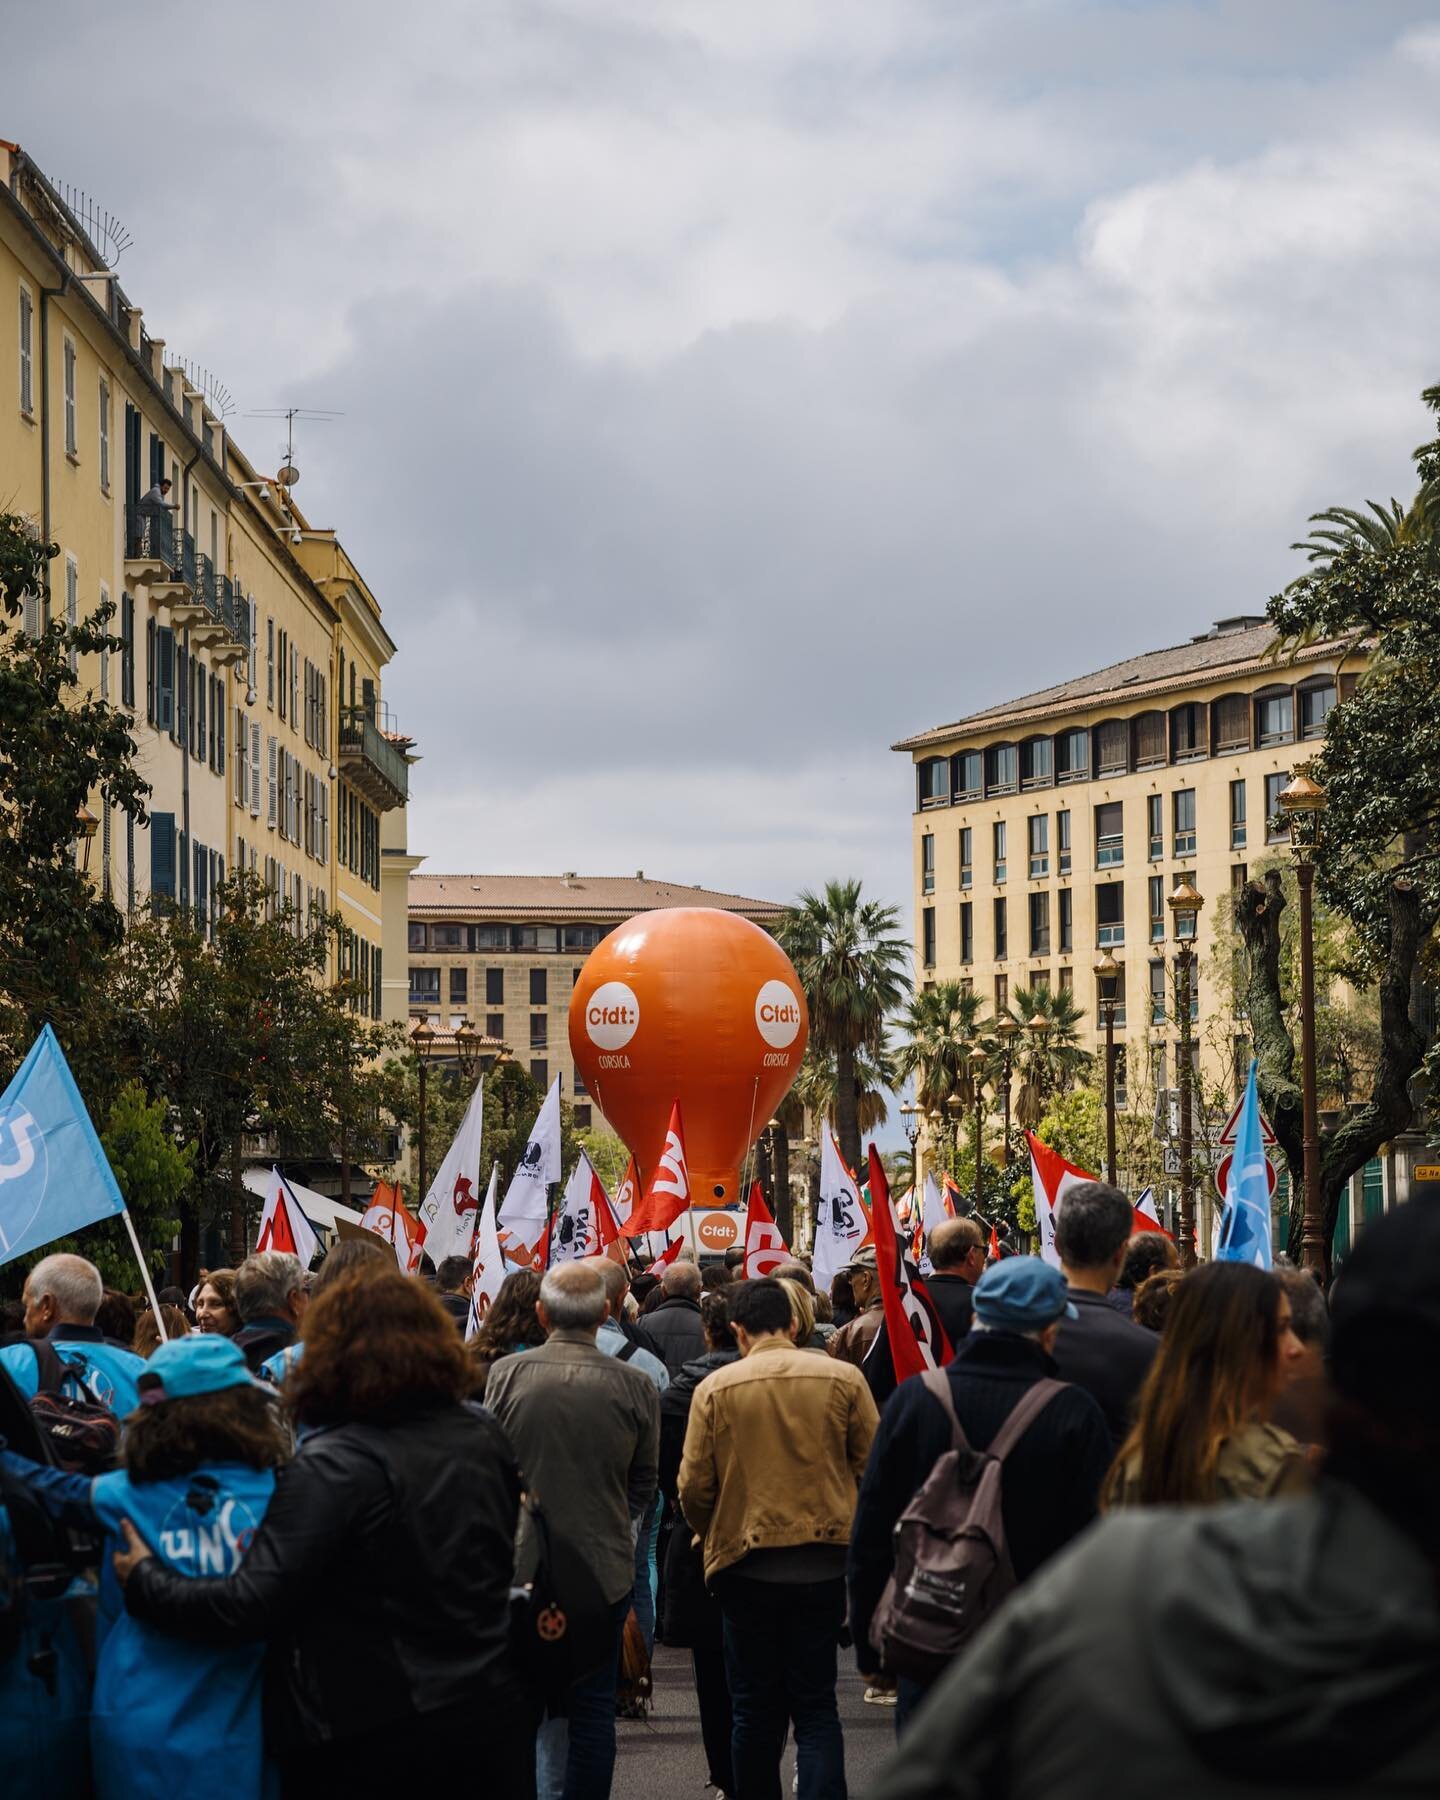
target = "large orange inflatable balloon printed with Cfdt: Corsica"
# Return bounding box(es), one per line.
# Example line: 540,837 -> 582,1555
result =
571,907 -> 810,1206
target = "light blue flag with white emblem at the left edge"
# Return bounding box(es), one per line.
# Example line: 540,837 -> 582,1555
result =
0,1026 -> 124,1264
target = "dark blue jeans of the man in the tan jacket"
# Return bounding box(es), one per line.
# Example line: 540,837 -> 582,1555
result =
711,1573 -> 846,1800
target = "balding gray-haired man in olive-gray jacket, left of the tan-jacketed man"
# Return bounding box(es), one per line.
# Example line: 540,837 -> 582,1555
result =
484,1260 -> 661,1800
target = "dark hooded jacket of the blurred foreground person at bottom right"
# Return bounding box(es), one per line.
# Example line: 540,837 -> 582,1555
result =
871,1481 -> 1440,1800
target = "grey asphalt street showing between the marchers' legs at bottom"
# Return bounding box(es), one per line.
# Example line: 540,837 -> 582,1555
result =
614,1643 -> 895,1800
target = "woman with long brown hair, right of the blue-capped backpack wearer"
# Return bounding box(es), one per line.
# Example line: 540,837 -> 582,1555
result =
1102,1262 -> 1309,1508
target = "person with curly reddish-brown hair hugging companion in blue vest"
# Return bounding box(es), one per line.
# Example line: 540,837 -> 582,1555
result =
115,1267 -> 535,1796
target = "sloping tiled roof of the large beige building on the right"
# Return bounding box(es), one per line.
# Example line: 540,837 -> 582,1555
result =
891,623 -> 1341,751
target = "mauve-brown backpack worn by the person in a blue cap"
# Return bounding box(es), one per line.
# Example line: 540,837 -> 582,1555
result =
869,1368 -> 1066,1681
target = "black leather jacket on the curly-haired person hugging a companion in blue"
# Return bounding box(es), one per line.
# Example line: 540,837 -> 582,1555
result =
124,1404 -> 520,1751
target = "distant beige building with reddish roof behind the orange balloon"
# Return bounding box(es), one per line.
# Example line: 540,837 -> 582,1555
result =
410,869 -> 785,1130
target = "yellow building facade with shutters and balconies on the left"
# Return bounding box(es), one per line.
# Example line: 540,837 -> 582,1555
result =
0,144 -> 410,1017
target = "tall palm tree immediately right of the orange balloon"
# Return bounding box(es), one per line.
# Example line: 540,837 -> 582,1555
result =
776,880 -> 911,1168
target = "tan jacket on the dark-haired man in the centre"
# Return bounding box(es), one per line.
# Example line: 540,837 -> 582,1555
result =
679,1341 -> 878,1580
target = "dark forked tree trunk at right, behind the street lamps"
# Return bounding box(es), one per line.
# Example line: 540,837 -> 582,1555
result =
1235,869 -> 1426,1262
